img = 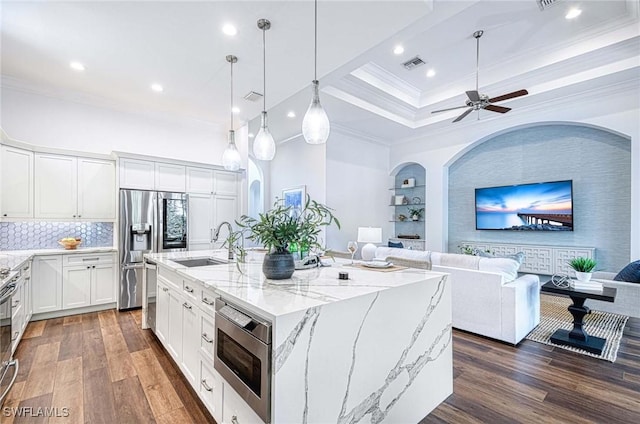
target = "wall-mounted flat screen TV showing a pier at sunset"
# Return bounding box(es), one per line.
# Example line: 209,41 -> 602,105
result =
476,180 -> 573,231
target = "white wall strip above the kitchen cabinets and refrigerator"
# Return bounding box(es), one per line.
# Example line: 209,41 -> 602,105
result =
0,87 -> 230,165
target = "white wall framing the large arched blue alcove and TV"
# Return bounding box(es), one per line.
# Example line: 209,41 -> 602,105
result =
389,84 -> 640,259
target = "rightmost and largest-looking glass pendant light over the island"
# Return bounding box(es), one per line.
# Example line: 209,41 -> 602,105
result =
302,0 -> 331,144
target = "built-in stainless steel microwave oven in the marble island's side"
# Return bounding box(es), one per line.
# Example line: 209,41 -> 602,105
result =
213,298 -> 271,423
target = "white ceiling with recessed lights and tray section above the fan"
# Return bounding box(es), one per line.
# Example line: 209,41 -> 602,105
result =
1,0 -> 640,144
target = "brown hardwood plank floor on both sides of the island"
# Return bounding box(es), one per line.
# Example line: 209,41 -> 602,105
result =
6,310 -> 640,424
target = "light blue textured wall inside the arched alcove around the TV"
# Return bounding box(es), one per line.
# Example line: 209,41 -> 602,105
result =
448,123 -> 631,270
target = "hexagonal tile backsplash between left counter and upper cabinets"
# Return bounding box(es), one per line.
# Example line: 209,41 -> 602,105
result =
0,222 -> 114,250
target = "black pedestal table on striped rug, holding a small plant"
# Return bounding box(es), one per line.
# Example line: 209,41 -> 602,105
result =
540,281 -> 616,355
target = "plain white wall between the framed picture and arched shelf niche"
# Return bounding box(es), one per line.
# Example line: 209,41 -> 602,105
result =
327,131 -> 393,251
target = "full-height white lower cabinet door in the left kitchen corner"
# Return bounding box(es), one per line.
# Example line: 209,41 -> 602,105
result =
31,255 -> 62,314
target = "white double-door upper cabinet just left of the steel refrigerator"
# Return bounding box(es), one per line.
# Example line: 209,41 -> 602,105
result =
34,153 -> 115,220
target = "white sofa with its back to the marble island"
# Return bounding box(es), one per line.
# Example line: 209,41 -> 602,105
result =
376,247 -> 540,345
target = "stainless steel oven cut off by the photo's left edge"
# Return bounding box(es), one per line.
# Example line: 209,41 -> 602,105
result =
0,276 -> 19,406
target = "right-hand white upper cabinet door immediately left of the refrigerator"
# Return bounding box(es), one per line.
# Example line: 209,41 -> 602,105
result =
78,158 -> 116,219
